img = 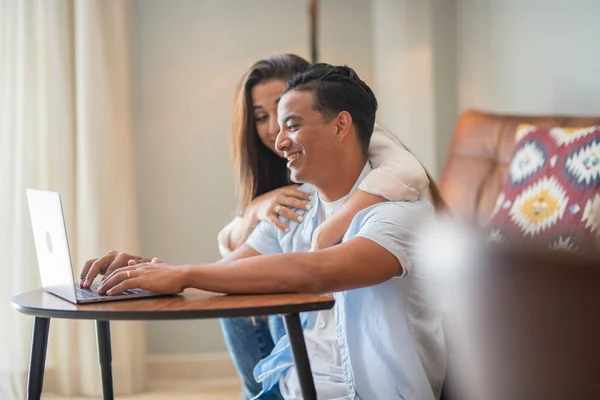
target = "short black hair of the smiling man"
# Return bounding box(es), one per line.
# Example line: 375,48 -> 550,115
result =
284,64 -> 377,155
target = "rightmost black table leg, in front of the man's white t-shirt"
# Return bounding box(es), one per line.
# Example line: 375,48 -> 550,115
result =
284,313 -> 317,400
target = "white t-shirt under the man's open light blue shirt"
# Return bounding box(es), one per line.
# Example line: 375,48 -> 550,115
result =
279,195 -> 349,400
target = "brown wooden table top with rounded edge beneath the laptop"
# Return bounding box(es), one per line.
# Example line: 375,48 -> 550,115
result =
11,289 -> 334,320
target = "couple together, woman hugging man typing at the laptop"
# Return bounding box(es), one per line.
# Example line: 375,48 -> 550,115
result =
81,54 -> 445,400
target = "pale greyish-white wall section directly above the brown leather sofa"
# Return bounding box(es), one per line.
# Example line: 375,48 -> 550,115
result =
458,0 -> 600,115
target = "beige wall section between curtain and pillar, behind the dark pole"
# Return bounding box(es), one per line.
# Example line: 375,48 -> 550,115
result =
133,0 -> 373,354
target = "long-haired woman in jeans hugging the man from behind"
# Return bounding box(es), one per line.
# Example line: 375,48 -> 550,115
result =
218,54 -> 441,398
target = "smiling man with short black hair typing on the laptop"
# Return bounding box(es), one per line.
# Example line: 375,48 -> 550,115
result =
88,64 -> 445,400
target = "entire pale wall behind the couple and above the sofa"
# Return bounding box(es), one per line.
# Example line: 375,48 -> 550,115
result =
133,0 -> 600,354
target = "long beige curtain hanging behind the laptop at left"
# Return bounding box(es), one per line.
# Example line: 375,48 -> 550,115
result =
0,0 -> 146,399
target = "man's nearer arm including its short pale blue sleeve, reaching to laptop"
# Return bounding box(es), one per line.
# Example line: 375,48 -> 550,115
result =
98,201 -> 422,294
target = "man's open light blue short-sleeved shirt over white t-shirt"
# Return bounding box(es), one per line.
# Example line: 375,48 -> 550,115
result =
247,163 -> 446,400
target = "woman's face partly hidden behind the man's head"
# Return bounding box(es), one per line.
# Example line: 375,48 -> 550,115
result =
252,79 -> 285,156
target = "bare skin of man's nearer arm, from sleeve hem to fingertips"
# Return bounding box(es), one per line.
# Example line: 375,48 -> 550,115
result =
98,237 -> 402,294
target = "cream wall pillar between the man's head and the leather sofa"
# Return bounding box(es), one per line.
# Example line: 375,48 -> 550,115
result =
372,0 -> 457,177
